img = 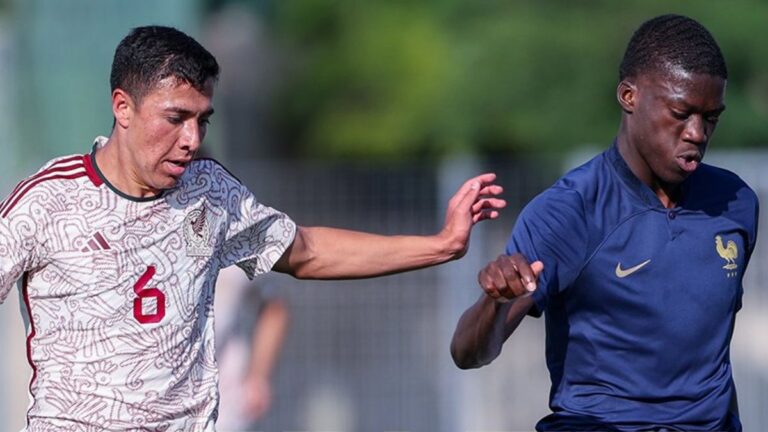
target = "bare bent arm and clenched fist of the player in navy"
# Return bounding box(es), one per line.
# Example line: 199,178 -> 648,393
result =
451,254 -> 544,369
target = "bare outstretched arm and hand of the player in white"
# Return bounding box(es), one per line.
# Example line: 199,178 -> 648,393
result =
274,174 -> 506,279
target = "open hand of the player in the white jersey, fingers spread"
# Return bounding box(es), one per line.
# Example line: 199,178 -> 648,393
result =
440,173 -> 507,258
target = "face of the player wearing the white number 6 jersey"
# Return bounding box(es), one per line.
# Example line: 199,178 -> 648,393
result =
127,77 -> 213,194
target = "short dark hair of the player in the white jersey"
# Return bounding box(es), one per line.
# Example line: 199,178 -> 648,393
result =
109,26 -> 219,102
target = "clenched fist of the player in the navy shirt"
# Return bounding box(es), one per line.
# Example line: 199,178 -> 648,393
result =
477,254 -> 544,303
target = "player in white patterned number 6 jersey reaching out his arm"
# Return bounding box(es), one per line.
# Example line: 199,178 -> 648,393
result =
0,26 -> 505,432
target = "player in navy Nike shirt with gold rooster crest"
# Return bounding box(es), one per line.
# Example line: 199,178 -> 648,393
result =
451,15 -> 758,431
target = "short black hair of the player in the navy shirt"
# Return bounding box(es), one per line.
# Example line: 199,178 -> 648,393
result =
619,15 -> 728,80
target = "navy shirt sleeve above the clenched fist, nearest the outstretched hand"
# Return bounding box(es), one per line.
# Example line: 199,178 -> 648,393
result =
506,186 -> 588,317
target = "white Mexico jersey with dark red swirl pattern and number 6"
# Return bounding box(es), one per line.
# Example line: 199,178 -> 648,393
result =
0,139 -> 296,432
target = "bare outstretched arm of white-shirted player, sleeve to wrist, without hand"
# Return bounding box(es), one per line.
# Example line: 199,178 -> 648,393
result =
288,227 -> 463,279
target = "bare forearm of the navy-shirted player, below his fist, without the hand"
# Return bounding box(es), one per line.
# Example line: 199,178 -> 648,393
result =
451,293 -> 533,369
